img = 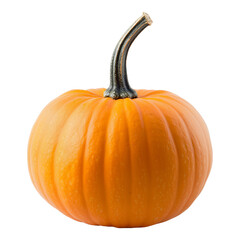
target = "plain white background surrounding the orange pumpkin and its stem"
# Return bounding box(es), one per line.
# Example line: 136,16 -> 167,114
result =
0,0 -> 240,240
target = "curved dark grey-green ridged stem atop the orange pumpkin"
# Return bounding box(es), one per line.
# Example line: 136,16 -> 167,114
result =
104,13 -> 152,100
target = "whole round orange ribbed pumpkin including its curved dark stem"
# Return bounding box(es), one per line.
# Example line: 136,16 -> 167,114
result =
28,13 -> 212,227
